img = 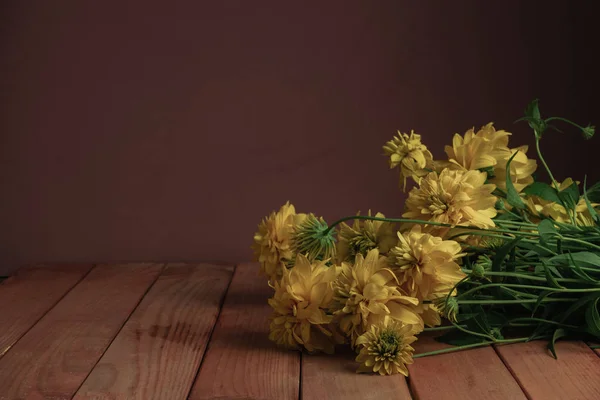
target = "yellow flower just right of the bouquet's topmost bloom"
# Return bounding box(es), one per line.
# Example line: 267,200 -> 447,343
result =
490,146 -> 537,192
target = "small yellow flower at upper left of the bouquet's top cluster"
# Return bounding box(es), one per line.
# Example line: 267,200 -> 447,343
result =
383,131 -> 433,188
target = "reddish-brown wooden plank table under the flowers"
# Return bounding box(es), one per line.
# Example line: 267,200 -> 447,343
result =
0,263 -> 600,400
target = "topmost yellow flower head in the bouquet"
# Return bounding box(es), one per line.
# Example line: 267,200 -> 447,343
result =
445,122 -> 510,170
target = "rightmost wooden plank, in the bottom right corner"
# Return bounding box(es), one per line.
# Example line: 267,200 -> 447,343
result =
497,340 -> 600,400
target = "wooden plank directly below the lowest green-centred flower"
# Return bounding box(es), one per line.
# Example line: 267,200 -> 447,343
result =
302,348 -> 411,400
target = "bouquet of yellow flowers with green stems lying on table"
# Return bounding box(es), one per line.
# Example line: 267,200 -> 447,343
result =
253,100 -> 600,375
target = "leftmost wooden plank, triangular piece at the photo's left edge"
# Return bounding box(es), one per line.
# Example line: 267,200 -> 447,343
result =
0,264 -> 92,358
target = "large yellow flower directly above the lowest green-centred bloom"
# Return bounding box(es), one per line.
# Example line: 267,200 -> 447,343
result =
332,249 -> 423,346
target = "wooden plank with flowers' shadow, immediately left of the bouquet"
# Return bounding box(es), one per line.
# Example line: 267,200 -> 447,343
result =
189,264 -> 300,400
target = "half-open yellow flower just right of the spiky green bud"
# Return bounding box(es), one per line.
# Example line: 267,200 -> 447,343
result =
337,210 -> 396,262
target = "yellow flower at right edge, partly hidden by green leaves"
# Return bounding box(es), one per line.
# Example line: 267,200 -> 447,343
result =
525,178 -> 600,226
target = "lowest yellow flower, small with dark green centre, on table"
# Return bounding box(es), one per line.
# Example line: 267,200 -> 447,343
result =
356,317 -> 417,376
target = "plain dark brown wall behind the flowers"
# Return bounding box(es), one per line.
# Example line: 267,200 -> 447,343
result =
0,0 -> 600,273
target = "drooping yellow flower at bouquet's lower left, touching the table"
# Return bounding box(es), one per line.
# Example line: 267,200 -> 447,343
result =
269,254 -> 337,353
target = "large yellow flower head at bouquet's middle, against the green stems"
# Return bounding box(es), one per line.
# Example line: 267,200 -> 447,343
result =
389,225 -> 466,301
